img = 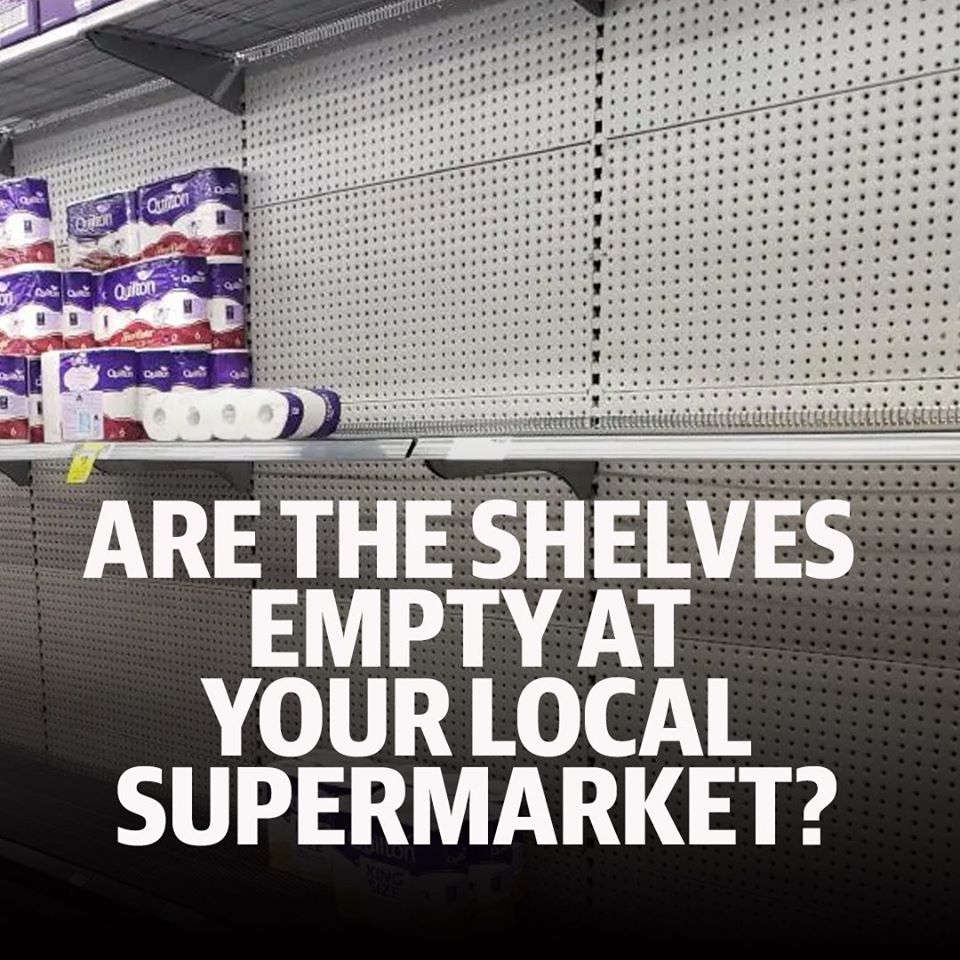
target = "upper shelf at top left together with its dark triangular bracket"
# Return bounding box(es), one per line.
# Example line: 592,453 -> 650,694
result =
0,0 -> 437,137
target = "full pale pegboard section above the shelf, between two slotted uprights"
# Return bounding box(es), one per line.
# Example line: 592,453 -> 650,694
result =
247,0 -> 596,431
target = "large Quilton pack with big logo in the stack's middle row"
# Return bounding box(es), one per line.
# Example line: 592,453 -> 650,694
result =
94,257 -> 210,349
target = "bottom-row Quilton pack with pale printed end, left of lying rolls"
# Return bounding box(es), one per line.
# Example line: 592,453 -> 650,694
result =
42,349 -> 143,443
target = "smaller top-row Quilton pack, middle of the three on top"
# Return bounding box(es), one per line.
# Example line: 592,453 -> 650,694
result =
67,192 -> 140,272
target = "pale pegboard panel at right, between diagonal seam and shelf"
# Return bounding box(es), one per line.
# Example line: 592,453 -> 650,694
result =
601,74 -> 960,428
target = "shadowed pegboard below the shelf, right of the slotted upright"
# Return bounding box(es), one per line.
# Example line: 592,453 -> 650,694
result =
592,463 -> 960,936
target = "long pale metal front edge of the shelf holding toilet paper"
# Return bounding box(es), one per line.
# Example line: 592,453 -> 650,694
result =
0,432 -> 960,464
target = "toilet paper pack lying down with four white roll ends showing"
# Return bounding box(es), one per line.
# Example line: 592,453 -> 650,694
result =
143,387 -> 340,442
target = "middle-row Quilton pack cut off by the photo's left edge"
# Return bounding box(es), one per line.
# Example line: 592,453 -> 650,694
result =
0,265 -> 63,356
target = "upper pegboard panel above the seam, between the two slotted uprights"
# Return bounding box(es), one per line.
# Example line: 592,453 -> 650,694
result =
247,0 -> 596,202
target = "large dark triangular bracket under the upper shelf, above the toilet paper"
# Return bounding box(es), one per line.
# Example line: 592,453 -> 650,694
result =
86,26 -> 244,114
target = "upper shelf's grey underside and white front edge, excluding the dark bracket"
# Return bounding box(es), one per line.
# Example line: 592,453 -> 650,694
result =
0,0 -> 437,132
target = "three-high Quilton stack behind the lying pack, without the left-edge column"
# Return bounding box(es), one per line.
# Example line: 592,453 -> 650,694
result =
34,168 -> 251,443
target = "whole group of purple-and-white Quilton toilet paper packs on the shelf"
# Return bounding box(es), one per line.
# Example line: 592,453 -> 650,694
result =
0,167 -> 340,443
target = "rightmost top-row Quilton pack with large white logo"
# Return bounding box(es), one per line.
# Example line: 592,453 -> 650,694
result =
138,167 -> 243,258
